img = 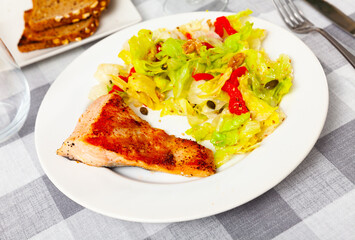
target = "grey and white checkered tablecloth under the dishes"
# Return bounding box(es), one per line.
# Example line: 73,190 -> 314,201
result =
0,0 -> 355,240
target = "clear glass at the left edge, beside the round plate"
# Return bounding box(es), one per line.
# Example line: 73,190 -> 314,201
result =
0,39 -> 30,143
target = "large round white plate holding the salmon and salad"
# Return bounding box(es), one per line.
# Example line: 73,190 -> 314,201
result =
35,12 -> 328,222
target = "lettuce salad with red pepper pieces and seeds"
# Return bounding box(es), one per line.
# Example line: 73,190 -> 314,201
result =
90,10 -> 292,167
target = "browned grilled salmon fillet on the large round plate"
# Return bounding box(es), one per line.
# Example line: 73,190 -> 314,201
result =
57,94 -> 216,177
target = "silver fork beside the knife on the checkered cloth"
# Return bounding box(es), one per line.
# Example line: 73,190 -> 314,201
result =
273,0 -> 355,68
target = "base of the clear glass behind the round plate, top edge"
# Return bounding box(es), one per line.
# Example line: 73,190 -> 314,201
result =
164,0 -> 228,14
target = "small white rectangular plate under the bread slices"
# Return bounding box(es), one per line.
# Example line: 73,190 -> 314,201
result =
0,0 -> 142,67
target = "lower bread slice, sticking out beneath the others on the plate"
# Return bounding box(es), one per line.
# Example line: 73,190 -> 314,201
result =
17,10 -> 99,52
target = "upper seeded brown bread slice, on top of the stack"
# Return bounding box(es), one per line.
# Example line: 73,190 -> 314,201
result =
28,0 -> 109,31
